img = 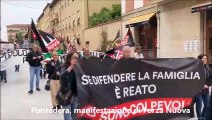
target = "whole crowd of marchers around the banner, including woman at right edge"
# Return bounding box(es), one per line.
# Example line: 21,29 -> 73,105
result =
1,41 -> 212,120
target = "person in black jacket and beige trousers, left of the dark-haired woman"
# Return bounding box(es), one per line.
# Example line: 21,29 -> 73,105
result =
46,52 -> 61,109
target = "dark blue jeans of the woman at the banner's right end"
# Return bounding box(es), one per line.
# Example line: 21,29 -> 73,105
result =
196,91 -> 210,120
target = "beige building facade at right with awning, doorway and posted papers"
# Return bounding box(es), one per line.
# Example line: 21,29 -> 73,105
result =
122,0 -> 212,63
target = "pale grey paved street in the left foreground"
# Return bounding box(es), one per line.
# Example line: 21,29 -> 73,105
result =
0,63 -> 63,120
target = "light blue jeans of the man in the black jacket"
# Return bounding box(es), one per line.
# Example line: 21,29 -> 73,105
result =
29,66 -> 40,90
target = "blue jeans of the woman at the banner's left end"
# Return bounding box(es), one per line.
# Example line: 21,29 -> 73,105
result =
63,96 -> 78,120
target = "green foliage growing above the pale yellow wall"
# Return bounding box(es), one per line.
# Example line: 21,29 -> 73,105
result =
89,4 -> 121,27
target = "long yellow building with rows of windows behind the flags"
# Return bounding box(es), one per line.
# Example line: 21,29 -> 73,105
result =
37,0 -> 121,50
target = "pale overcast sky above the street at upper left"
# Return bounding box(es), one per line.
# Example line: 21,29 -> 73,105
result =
1,0 -> 52,41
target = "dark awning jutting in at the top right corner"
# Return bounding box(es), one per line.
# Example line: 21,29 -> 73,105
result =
191,1 -> 212,13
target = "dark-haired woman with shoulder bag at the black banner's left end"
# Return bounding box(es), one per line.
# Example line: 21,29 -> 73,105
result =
60,52 -> 79,120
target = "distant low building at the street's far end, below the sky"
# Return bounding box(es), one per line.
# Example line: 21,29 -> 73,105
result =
6,24 -> 30,42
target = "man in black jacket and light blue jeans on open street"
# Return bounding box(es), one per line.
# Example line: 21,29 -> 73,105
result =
26,44 -> 43,94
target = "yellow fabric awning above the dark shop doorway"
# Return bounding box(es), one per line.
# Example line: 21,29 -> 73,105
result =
128,12 -> 155,25
